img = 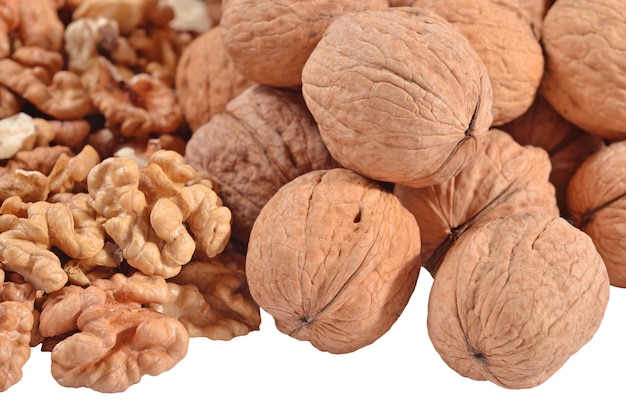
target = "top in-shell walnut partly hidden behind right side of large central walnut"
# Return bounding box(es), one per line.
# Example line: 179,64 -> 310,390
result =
412,0 -> 543,126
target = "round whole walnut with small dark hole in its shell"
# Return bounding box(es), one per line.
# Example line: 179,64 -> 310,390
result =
246,168 -> 420,353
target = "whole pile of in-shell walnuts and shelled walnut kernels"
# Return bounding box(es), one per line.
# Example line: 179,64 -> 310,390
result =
0,0 -> 626,392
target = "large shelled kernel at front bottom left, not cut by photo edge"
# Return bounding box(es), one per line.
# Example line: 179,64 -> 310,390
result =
48,274 -> 189,392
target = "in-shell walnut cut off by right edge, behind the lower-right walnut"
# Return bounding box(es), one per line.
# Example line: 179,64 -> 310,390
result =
567,141 -> 626,287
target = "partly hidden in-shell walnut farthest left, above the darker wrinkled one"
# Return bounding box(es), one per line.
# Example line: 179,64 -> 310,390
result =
175,26 -> 253,131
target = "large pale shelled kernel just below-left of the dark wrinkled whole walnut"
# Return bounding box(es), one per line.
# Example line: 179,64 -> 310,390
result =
87,150 -> 231,278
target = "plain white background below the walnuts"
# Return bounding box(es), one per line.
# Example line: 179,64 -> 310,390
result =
0,269 -> 626,417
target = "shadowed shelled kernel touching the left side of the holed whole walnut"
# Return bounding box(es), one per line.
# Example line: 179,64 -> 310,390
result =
148,256 -> 261,340
